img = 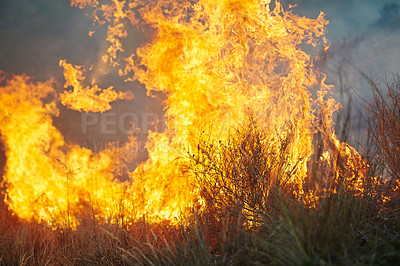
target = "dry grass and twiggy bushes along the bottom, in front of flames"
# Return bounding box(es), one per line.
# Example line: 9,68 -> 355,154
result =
0,76 -> 400,265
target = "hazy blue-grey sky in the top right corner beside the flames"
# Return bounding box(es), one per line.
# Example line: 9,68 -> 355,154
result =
290,0 -> 400,84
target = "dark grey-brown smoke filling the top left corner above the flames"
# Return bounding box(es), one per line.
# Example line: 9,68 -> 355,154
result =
0,0 -> 100,80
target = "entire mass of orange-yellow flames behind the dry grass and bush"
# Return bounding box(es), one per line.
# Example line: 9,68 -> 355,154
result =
0,0 -> 364,229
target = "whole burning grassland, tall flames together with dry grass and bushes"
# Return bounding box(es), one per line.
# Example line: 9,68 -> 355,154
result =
0,0 -> 400,265
